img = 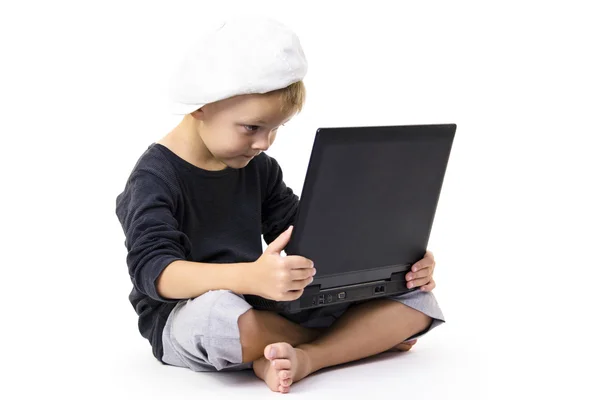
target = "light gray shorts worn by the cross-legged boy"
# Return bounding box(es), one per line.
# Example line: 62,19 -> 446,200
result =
162,290 -> 445,371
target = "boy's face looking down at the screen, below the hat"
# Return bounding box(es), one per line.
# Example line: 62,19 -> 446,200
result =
192,93 -> 292,168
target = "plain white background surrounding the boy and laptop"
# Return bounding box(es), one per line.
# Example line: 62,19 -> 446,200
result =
0,0 -> 600,399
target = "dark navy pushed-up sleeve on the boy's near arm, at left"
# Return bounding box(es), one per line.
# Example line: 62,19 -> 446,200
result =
116,170 -> 191,302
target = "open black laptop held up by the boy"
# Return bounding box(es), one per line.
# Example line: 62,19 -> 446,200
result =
245,124 -> 456,313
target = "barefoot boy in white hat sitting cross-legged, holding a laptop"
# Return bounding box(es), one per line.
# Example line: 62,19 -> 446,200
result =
116,18 -> 444,393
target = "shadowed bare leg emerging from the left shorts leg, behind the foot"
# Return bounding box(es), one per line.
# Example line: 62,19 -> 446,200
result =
238,309 -> 320,363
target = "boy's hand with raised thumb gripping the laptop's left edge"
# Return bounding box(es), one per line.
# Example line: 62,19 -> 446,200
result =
249,226 -> 317,301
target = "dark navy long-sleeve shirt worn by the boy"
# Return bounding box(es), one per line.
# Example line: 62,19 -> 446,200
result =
116,143 -> 299,362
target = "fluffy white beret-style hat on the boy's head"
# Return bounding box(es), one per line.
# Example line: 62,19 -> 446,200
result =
170,18 -> 308,115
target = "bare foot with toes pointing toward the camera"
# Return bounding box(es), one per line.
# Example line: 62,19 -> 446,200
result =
253,343 -> 310,393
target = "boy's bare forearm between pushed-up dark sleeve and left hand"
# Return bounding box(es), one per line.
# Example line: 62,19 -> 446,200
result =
156,260 -> 253,299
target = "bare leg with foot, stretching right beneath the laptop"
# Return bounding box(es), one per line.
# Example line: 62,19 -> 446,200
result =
254,299 -> 431,393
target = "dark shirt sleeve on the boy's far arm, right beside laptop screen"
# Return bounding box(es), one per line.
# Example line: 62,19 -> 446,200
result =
262,157 -> 299,244
